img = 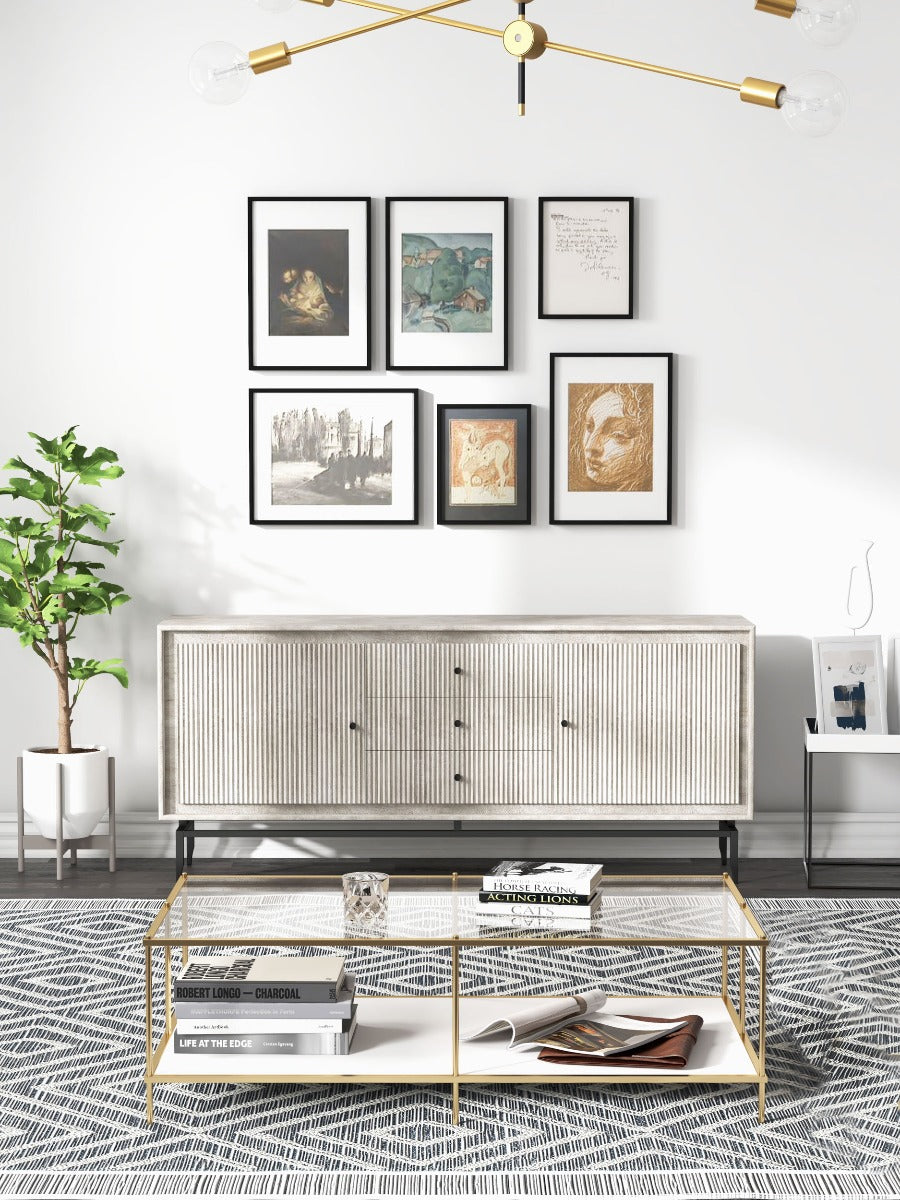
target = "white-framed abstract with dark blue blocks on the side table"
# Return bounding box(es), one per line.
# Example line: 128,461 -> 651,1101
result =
812,634 -> 888,734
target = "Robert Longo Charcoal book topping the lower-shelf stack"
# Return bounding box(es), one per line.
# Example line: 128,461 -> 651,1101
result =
174,954 -> 346,1004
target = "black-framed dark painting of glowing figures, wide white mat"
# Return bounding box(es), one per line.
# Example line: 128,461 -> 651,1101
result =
247,196 -> 372,371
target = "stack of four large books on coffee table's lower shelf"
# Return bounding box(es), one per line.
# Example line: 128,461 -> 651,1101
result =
174,954 -> 356,1055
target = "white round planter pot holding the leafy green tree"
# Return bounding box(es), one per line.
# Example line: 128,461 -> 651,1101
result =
22,746 -> 109,839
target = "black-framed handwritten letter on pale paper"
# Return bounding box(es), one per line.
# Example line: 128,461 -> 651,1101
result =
538,196 -> 635,319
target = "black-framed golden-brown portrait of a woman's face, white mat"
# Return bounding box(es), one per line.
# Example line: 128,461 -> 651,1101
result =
550,353 -> 673,524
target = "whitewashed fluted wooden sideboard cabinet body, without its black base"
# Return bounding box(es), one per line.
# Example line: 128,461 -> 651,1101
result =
158,617 -> 754,823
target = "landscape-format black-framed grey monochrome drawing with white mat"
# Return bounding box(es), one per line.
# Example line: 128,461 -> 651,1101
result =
250,388 -> 419,524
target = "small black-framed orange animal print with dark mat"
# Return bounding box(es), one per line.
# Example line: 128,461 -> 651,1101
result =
436,404 -> 532,524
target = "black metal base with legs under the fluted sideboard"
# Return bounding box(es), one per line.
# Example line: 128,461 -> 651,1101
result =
175,821 -> 739,883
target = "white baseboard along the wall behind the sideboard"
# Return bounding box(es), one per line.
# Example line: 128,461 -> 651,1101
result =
0,812 -> 900,860
